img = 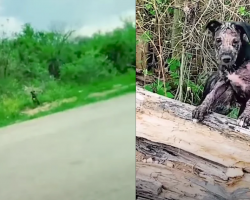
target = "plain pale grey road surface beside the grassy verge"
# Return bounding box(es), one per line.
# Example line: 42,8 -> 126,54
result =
0,94 -> 135,200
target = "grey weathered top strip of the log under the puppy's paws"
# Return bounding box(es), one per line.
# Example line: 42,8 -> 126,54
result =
136,87 -> 250,140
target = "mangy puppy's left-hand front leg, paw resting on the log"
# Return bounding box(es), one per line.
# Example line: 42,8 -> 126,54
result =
192,79 -> 228,121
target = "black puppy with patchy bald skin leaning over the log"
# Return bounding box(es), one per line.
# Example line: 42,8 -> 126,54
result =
192,20 -> 250,125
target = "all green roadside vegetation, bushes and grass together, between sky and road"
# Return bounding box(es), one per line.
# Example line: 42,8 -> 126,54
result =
0,20 -> 136,127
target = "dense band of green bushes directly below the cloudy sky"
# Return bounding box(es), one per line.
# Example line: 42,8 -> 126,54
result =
0,24 -> 136,83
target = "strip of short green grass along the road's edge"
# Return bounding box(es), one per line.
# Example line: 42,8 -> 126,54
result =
0,73 -> 135,127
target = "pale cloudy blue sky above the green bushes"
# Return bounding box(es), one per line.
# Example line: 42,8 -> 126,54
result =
0,0 -> 135,35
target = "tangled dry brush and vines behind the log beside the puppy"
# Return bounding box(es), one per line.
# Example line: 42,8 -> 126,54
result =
136,0 -> 250,104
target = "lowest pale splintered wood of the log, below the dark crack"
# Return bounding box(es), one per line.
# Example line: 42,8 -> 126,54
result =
136,159 -> 250,200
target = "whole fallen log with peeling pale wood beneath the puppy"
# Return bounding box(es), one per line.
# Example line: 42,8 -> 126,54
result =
136,87 -> 250,200
